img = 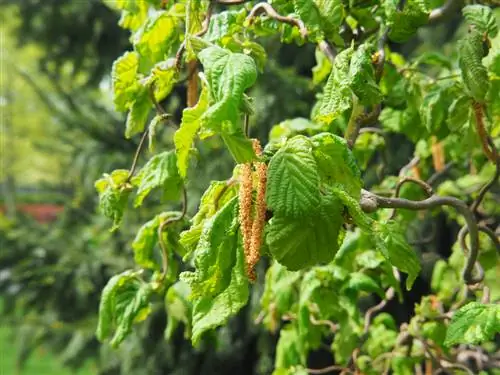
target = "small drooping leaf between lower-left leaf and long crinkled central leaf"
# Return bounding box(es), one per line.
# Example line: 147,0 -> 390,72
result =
165,281 -> 192,340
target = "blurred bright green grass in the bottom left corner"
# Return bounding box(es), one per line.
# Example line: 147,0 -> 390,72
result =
0,326 -> 95,375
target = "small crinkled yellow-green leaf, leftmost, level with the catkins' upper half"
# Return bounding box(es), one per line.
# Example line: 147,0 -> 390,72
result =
95,169 -> 132,230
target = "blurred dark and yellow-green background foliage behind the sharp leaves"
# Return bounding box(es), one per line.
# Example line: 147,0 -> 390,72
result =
0,0 -> 498,375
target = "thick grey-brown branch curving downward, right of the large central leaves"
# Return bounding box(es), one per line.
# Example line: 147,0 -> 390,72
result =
360,190 -> 482,285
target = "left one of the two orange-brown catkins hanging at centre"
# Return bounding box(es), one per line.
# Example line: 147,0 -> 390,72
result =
239,163 -> 253,265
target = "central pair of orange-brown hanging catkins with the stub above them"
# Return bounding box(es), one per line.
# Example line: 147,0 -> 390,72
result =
239,139 -> 267,282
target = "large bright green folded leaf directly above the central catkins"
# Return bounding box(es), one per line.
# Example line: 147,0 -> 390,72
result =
198,46 -> 257,163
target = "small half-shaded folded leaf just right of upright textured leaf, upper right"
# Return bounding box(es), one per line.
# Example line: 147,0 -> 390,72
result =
349,44 -> 382,105
